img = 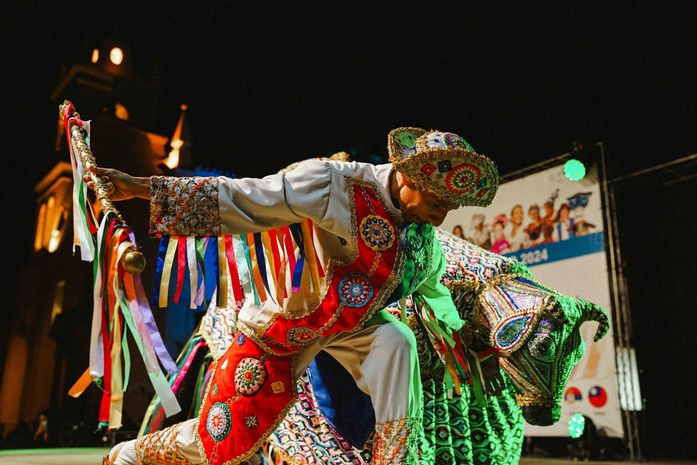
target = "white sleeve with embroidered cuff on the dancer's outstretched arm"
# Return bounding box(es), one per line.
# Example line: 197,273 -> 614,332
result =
150,160 -> 333,236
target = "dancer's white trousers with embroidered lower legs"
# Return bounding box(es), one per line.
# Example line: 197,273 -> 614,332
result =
109,310 -> 422,465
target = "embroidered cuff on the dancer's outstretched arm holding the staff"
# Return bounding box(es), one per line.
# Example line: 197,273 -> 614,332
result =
150,176 -> 220,237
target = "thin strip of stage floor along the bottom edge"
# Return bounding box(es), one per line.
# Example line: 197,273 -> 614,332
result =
0,448 -> 697,465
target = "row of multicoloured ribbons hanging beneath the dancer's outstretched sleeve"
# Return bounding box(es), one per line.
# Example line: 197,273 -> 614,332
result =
153,221 -> 325,309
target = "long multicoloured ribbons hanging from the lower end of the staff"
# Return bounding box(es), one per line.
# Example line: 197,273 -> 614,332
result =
69,214 -> 181,429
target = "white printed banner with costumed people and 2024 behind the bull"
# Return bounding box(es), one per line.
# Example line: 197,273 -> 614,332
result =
441,161 -> 623,437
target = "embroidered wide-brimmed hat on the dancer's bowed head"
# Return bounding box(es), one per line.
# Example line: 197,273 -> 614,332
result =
387,128 -> 499,207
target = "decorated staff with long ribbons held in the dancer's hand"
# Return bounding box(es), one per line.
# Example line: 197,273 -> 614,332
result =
59,100 -> 181,429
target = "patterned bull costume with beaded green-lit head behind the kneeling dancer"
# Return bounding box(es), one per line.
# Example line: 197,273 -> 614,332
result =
144,224 -> 608,465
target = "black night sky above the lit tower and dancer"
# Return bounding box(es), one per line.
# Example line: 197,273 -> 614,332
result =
0,1 -> 697,456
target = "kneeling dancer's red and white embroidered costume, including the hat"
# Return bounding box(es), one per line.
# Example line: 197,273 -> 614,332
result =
110,128 -> 498,464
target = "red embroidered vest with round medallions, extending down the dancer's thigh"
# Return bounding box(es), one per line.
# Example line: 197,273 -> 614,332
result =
197,178 -> 404,465
